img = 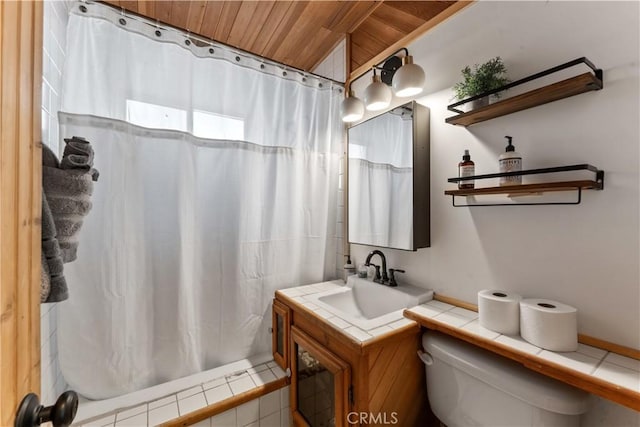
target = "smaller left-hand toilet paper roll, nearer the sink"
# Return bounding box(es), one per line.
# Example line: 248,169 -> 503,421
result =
478,289 -> 522,335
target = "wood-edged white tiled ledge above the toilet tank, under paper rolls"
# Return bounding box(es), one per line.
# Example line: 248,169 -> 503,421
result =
405,300 -> 640,411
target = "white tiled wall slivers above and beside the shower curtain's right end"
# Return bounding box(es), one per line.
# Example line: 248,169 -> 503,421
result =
313,39 -> 346,278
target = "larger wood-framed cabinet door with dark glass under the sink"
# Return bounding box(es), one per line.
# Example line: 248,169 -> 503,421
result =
290,326 -> 351,427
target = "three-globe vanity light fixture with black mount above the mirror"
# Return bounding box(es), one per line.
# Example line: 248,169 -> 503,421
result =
340,47 -> 425,123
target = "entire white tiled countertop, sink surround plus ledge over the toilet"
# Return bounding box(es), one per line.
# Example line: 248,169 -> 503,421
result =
276,280 -> 640,411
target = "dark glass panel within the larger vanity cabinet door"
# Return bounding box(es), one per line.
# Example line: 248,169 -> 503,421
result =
296,345 -> 336,427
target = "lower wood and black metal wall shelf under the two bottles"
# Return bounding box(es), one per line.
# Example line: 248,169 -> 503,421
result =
444,164 -> 604,207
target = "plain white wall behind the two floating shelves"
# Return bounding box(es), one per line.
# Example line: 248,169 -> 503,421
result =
351,1 -> 640,425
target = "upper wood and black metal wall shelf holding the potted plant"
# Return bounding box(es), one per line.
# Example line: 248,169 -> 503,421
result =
445,57 -> 603,127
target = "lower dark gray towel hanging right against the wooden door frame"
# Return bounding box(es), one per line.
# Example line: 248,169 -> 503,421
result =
40,193 -> 69,302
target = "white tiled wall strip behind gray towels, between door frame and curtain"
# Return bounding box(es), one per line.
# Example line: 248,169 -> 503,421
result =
40,1 -> 69,405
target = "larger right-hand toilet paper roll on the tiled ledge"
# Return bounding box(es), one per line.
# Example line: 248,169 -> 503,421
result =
520,298 -> 578,351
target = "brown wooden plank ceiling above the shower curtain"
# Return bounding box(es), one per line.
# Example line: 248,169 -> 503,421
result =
105,0 -> 456,77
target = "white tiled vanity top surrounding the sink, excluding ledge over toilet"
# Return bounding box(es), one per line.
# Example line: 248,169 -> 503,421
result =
276,279 -> 417,344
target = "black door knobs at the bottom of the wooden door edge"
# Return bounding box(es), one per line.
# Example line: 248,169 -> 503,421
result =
14,390 -> 78,427
